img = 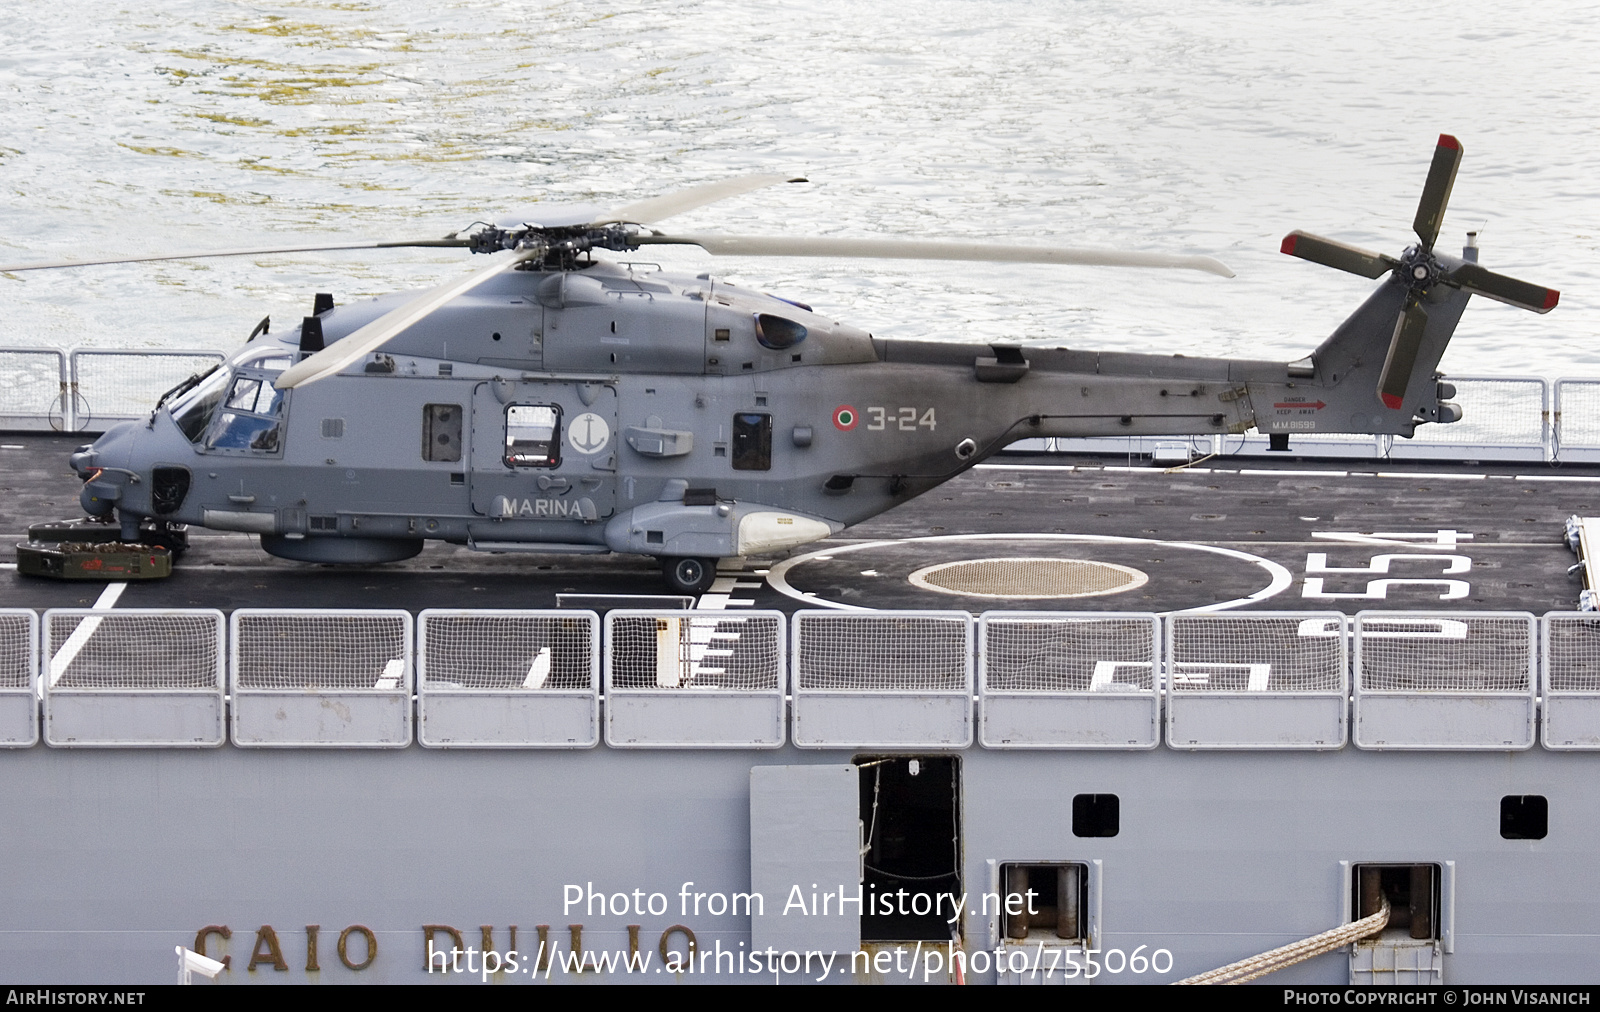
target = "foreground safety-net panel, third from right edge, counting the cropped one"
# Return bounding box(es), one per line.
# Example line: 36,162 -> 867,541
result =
1168,615 -> 1346,692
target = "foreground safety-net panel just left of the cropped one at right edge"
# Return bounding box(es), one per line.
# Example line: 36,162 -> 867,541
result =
1355,612 -> 1533,693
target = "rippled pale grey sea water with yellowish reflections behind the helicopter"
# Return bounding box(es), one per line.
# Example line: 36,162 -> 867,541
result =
0,0 -> 1600,376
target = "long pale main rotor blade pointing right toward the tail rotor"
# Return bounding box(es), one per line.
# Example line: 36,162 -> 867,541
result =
634,235 -> 1234,277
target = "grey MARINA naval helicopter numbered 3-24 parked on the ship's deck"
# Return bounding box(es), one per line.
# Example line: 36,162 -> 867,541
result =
0,135 -> 1558,592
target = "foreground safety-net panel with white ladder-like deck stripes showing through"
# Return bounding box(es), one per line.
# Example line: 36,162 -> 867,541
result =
606,612 -> 784,692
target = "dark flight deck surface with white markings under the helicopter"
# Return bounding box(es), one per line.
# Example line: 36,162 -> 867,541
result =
0,434 -> 1600,613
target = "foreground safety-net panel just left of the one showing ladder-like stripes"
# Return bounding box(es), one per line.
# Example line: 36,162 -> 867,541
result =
421,613 -> 598,692
